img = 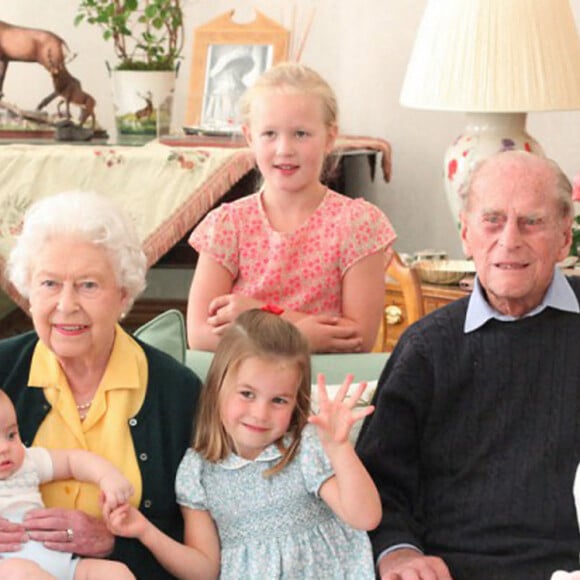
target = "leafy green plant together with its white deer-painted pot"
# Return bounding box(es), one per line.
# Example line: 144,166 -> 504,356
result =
74,0 -> 184,137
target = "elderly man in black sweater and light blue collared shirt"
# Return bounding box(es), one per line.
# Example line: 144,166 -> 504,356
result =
357,152 -> 580,580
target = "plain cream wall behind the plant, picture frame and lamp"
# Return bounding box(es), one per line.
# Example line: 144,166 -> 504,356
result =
0,0 -> 580,257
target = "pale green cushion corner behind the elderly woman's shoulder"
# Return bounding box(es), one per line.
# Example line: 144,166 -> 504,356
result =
133,309 -> 187,364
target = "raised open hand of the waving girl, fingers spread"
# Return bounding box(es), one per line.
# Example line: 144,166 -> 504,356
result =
308,373 -> 375,445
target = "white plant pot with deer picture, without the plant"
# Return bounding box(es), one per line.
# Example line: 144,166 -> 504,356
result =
110,70 -> 177,142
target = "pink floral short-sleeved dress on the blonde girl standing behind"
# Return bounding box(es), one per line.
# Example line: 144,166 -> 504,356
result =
189,191 -> 396,315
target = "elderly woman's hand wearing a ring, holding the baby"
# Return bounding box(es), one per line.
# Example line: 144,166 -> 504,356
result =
23,508 -> 115,558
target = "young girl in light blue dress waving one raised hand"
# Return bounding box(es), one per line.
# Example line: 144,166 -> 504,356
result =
106,310 -> 381,580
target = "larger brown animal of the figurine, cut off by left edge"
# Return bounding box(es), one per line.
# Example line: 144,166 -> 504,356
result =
0,20 -> 68,97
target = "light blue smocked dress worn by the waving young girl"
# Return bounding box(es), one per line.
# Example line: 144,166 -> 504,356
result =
175,425 -> 375,580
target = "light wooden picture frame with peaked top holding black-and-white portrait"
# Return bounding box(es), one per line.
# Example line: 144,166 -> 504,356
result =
185,10 -> 290,133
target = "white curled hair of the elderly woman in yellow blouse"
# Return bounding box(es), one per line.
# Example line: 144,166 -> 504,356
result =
6,190 -> 147,308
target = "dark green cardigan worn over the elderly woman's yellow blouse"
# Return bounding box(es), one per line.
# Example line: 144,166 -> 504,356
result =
0,332 -> 201,580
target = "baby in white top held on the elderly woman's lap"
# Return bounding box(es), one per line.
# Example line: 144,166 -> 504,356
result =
0,390 -> 135,580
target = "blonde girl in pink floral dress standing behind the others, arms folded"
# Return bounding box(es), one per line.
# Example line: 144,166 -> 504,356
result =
187,63 -> 396,352
